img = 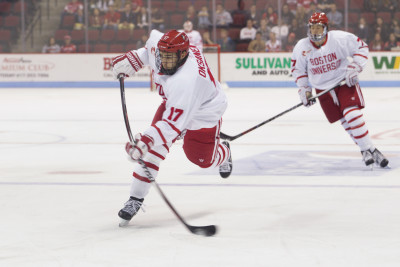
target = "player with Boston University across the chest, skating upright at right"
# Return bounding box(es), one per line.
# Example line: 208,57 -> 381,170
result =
292,12 -> 389,167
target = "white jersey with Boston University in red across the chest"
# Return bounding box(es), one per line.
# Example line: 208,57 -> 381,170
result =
292,31 -> 369,90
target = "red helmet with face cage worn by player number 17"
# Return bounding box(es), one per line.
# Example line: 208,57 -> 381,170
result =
156,30 -> 189,75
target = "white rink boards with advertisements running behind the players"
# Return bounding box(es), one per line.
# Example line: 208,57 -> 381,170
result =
0,52 -> 400,87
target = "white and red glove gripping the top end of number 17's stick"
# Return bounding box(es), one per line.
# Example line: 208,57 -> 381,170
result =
112,51 -> 143,80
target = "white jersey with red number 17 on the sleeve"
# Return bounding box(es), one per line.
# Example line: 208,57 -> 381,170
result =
133,30 -> 227,148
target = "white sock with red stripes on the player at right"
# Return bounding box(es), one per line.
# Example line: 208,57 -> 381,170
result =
343,106 -> 374,151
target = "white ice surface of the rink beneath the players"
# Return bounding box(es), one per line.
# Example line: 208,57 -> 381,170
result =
0,87 -> 400,267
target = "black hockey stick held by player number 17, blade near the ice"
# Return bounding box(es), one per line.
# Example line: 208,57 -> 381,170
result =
118,75 -> 217,236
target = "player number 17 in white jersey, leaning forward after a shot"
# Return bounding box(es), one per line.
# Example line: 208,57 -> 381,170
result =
113,30 -> 232,226
